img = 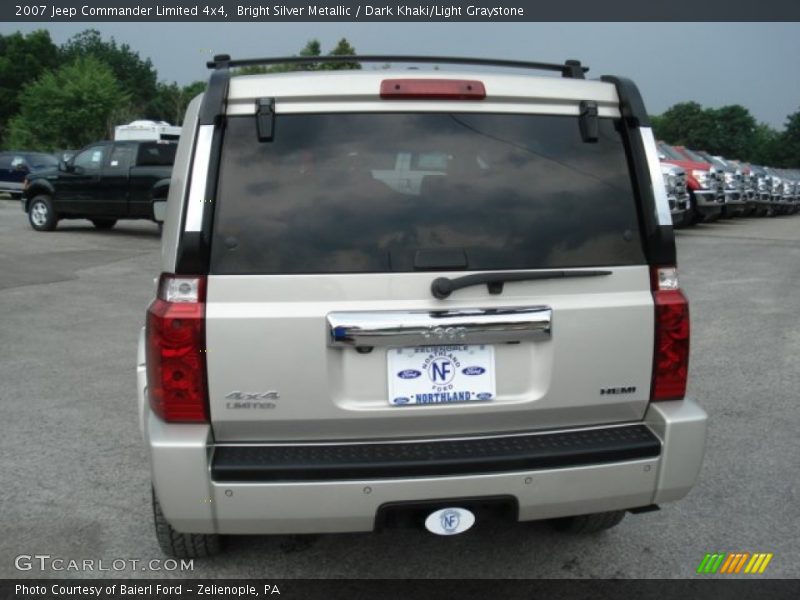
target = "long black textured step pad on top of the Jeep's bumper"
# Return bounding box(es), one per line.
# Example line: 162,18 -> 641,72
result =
211,424 -> 661,483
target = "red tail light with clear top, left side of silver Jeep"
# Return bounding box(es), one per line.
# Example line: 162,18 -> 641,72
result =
146,274 -> 208,423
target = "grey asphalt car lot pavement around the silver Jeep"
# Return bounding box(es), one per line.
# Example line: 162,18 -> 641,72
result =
0,199 -> 800,578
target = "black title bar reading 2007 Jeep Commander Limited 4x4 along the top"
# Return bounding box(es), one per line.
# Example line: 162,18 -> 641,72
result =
0,0 -> 800,23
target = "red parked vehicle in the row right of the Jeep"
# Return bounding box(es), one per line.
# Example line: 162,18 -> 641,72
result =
658,142 -> 725,223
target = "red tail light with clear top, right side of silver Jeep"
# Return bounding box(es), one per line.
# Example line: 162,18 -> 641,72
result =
650,267 -> 689,401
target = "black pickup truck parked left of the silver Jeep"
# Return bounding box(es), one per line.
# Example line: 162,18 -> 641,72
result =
22,141 -> 177,231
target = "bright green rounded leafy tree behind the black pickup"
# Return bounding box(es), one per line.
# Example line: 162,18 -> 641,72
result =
8,56 -> 130,151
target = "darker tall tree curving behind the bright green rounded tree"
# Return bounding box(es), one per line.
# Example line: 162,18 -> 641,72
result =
61,29 -> 158,115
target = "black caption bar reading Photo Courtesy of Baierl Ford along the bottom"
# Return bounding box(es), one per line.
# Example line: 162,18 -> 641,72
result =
0,580 -> 797,600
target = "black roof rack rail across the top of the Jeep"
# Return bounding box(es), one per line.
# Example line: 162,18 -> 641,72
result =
206,54 -> 589,79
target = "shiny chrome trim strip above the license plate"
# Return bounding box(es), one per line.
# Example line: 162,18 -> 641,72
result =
327,306 -> 553,347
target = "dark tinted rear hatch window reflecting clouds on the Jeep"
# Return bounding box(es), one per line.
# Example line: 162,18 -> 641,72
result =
211,113 -> 645,274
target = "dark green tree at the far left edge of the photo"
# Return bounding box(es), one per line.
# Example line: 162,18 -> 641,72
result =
0,29 -> 58,145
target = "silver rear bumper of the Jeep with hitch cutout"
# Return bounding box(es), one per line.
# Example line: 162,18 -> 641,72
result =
140,398 -> 707,534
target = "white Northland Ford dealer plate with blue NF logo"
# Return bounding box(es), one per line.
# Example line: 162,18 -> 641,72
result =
387,345 -> 496,406
